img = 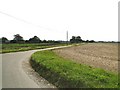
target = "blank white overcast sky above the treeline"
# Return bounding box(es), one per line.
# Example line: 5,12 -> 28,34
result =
0,0 -> 119,41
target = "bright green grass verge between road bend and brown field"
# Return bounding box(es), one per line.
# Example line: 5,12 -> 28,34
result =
30,50 -> 118,88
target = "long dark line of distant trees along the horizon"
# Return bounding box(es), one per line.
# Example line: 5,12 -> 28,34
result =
0,34 -> 120,43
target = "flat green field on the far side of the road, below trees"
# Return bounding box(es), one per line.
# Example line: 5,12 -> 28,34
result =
0,43 -> 65,53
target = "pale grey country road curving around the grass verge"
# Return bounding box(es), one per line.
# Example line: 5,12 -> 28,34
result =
1,46 -> 69,88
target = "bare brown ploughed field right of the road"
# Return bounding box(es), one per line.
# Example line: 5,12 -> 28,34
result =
54,43 -> 120,72
